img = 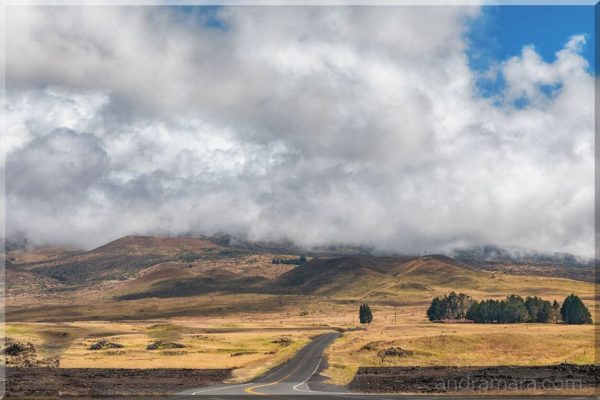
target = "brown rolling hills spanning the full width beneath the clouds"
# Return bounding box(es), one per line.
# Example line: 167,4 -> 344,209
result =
7,236 -> 589,301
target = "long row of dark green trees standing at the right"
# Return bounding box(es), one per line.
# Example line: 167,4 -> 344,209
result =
427,292 -> 592,324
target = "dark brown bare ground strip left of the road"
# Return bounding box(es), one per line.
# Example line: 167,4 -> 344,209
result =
6,368 -> 232,398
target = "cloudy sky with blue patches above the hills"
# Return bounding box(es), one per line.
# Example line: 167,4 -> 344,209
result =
1,6 -> 594,257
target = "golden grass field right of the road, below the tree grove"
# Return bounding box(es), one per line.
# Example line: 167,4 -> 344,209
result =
324,307 -> 598,384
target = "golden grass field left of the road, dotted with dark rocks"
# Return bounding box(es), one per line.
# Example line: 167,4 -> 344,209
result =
6,320 -> 325,380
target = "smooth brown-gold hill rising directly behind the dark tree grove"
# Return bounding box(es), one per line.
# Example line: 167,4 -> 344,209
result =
271,257 -> 594,304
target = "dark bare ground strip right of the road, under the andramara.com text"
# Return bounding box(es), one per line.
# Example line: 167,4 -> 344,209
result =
349,364 -> 600,393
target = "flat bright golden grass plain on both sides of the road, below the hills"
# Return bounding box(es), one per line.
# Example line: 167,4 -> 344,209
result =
7,295 -> 597,384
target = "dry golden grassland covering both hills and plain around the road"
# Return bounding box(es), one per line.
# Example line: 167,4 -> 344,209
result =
4,239 -> 598,384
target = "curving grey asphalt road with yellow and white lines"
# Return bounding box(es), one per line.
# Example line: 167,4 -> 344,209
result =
180,332 -> 339,398
